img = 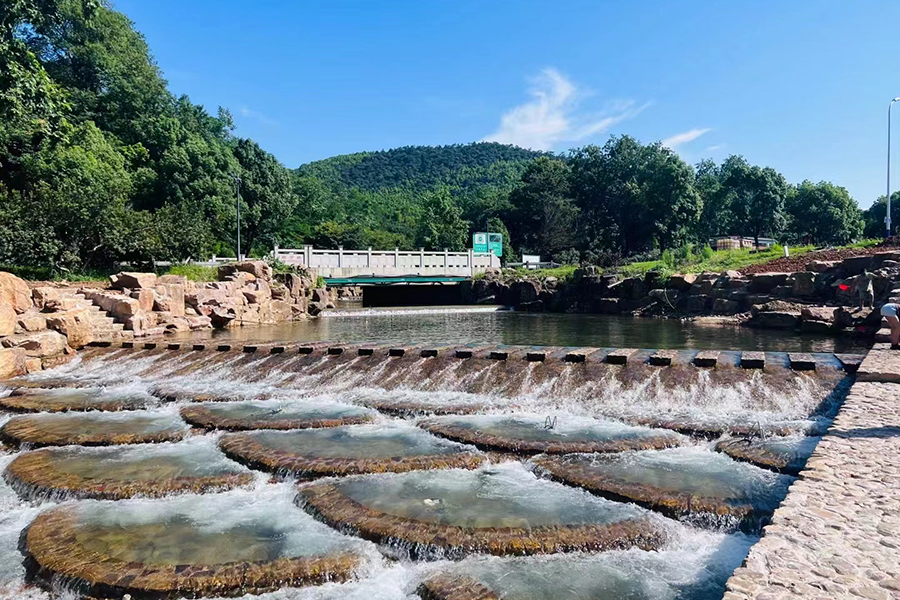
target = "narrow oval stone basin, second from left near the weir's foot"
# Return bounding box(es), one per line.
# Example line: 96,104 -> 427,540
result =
181,400 -> 373,431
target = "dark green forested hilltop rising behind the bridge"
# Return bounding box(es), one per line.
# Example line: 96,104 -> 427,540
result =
296,142 -> 542,191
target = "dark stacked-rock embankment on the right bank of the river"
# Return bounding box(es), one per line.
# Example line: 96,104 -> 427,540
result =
464,251 -> 900,333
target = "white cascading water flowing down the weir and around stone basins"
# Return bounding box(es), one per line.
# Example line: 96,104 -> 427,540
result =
0,347 -> 846,600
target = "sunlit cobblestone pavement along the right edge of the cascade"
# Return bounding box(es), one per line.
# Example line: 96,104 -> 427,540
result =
724,350 -> 900,600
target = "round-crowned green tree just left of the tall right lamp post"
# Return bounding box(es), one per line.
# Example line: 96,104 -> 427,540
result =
786,180 -> 863,244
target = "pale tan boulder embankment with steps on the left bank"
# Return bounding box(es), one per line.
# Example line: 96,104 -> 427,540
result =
0,261 -> 334,379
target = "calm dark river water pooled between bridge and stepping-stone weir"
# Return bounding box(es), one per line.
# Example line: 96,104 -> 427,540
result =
172,306 -> 866,353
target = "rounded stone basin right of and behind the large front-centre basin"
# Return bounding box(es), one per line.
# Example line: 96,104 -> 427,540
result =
534,447 -> 793,520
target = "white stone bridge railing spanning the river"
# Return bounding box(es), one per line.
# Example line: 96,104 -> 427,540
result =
272,246 -> 500,278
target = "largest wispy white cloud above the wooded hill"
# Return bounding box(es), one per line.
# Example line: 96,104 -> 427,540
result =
484,68 -> 649,150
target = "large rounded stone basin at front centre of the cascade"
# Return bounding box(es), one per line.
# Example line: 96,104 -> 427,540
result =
298,463 -> 665,558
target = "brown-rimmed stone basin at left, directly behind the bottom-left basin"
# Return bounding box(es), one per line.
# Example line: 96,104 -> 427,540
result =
3,439 -> 253,500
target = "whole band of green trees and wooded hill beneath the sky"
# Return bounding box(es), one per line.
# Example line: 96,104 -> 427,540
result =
0,0 -> 900,270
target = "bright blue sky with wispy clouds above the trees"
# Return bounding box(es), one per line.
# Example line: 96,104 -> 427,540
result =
115,0 -> 900,208
